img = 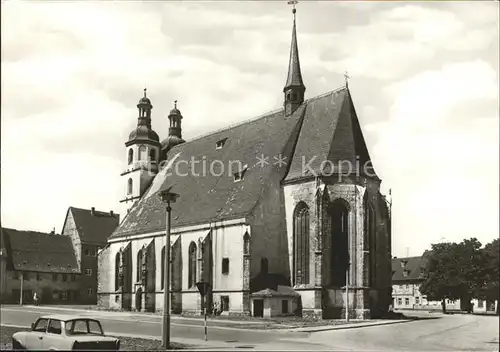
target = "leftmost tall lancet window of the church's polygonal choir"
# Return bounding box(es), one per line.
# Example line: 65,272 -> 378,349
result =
293,202 -> 310,285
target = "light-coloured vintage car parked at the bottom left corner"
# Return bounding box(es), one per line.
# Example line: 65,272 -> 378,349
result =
12,315 -> 120,351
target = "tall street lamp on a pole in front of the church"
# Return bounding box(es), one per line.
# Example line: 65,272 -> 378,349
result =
159,187 -> 179,349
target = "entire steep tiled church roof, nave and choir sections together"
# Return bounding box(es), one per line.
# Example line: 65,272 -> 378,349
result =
110,88 -> 376,238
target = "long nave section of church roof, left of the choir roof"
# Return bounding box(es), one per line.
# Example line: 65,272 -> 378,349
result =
111,104 -> 303,238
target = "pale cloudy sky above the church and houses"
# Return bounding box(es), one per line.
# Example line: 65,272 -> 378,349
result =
1,1 -> 499,256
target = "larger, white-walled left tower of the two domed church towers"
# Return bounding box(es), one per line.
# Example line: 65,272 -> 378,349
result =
120,89 -> 160,211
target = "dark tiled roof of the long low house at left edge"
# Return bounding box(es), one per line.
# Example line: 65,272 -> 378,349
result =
2,227 -> 78,273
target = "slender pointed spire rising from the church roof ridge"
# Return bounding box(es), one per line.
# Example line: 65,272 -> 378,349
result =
283,1 -> 306,116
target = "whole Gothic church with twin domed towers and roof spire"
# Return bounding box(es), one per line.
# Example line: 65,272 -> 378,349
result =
98,9 -> 392,319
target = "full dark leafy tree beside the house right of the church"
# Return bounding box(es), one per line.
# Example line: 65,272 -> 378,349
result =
420,238 -> 483,313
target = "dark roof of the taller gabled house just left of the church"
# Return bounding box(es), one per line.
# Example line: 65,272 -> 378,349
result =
68,207 -> 120,245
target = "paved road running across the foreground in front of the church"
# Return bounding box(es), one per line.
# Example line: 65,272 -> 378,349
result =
0,306 -> 499,351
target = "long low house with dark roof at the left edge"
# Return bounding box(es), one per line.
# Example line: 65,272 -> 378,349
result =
0,227 -> 80,303
